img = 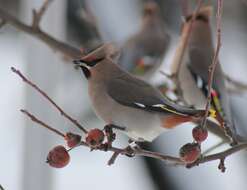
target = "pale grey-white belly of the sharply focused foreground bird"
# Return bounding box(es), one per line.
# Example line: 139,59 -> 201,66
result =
90,84 -> 166,141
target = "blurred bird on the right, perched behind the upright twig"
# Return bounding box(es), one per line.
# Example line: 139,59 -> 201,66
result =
172,6 -> 236,141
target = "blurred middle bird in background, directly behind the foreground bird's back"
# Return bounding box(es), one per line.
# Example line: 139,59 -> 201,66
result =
119,2 -> 170,76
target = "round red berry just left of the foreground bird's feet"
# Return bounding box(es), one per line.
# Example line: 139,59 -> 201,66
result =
86,129 -> 105,147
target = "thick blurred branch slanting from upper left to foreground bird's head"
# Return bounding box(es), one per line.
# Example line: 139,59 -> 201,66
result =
0,8 -> 81,59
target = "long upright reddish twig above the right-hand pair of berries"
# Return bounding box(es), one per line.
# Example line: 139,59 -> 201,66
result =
202,0 -> 223,128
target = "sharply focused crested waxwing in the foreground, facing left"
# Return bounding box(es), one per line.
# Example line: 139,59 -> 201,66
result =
74,44 -> 205,141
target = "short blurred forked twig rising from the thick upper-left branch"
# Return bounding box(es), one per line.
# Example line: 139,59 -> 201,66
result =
32,0 -> 53,29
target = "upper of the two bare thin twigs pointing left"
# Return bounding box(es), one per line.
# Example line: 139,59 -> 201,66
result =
11,67 -> 87,133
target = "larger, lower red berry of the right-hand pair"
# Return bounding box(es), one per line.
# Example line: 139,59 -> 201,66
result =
179,143 -> 201,163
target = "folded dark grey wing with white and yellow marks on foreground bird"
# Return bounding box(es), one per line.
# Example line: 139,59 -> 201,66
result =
107,74 -> 204,116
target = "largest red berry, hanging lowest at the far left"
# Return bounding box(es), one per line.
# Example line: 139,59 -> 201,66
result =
46,145 -> 70,168
